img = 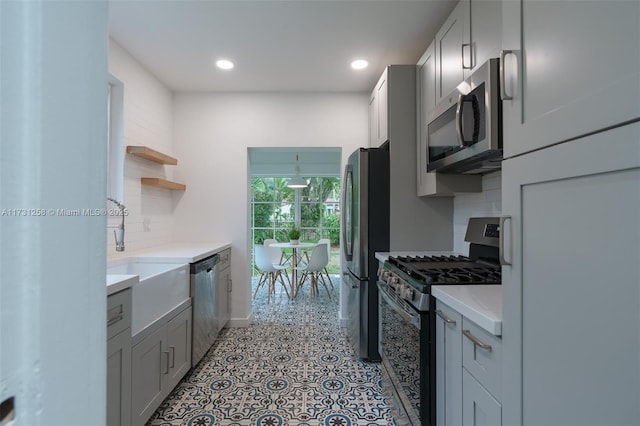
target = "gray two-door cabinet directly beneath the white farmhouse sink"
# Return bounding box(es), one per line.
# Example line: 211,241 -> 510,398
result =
131,307 -> 191,425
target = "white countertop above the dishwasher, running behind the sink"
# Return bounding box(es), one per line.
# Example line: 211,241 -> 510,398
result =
108,242 -> 231,263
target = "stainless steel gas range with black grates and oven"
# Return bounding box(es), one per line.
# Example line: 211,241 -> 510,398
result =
377,217 -> 501,426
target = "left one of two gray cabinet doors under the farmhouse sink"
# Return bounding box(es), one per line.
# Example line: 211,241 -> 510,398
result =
131,327 -> 164,425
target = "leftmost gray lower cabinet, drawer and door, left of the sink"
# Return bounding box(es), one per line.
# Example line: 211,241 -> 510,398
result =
107,289 -> 131,426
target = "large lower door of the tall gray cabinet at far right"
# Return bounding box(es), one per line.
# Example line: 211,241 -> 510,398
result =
502,123 -> 640,426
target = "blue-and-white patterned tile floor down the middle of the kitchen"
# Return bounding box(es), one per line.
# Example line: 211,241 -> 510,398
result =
147,276 -> 395,426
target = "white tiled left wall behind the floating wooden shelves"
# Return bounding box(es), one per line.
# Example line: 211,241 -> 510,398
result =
107,39 -> 176,256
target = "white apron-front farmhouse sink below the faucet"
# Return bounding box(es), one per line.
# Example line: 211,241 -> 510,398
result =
107,258 -> 189,336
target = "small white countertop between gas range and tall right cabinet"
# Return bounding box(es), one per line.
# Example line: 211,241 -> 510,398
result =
431,284 -> 502,336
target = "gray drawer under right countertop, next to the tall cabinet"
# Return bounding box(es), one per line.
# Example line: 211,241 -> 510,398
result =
462,318 -> 502,400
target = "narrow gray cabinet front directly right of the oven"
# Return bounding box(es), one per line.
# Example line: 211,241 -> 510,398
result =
436,301 -> 462,426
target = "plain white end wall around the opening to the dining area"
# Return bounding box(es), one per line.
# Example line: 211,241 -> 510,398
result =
173,93 -> 368,325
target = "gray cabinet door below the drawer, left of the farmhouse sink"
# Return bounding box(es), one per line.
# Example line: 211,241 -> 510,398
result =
107,328 -> 131,426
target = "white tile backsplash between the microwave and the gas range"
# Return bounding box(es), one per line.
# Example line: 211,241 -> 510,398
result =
453,171 -> 502,254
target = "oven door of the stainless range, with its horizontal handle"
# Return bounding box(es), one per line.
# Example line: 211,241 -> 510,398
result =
378,282 -> 428,426
